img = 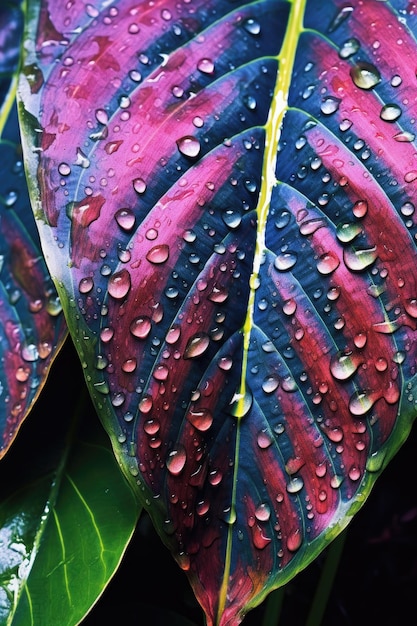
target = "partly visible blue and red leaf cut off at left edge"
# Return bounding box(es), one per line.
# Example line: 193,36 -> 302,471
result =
0,2 -> 66,458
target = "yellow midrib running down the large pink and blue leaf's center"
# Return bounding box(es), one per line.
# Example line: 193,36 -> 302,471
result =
216,0 -> 307,625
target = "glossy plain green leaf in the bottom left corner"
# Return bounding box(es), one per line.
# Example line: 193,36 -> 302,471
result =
0,346 -> 140,626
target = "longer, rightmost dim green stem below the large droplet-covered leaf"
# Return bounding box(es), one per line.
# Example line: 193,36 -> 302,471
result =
306,530 -> 347,626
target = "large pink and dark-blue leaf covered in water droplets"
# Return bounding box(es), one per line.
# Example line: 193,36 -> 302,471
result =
20,0 -> 417,626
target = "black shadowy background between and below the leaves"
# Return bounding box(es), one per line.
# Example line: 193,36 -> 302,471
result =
7,342 -> 417,626
